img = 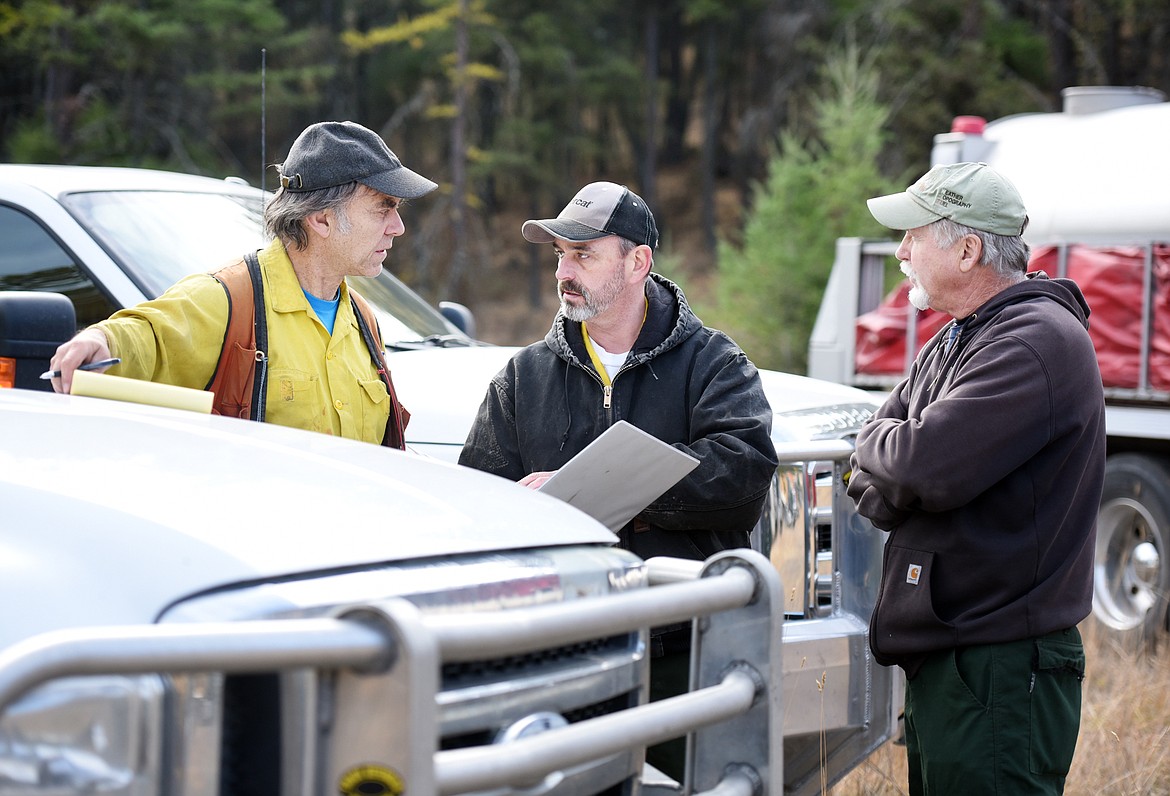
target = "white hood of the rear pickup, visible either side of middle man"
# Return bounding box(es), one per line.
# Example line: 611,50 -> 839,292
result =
388,345 -> 879,461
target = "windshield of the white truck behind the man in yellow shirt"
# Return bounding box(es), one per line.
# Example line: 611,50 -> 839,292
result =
63,190 -> 460,345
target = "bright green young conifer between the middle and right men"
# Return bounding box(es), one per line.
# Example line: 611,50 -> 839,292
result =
713,46 -> 904,372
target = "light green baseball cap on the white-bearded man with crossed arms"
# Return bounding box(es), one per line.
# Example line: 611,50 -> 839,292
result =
866,163 -> 1027,235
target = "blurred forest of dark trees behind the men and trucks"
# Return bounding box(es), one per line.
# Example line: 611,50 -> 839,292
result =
0,0 -> 1170,372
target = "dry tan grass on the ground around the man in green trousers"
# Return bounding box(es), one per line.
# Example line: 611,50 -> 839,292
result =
830,627 -> 1170,796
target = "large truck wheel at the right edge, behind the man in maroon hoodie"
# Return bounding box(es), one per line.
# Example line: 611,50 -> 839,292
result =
1093,453 -> 1170,650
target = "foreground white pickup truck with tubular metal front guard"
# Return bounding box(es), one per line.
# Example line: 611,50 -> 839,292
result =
0,381 -> 782,796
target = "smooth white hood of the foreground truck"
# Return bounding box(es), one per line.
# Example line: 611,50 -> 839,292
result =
0,390 -> 615,646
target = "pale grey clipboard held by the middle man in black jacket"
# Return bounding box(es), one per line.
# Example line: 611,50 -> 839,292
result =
541,420 -> 698,533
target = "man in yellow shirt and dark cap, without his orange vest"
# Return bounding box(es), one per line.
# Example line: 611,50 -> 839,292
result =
51,122 -> 436,445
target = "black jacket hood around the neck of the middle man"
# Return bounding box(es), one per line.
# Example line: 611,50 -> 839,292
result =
544,273 -> 703,368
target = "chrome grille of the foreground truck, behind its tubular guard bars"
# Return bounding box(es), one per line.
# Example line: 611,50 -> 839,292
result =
165,548 -> 647,796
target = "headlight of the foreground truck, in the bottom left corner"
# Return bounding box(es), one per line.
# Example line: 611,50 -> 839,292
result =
0,677 -> 163,796
